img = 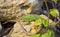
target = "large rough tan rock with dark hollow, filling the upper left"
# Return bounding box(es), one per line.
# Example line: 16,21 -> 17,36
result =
0,0 -> 43,20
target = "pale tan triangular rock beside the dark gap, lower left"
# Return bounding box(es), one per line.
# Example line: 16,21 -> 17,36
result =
10,23 -> 29,37
